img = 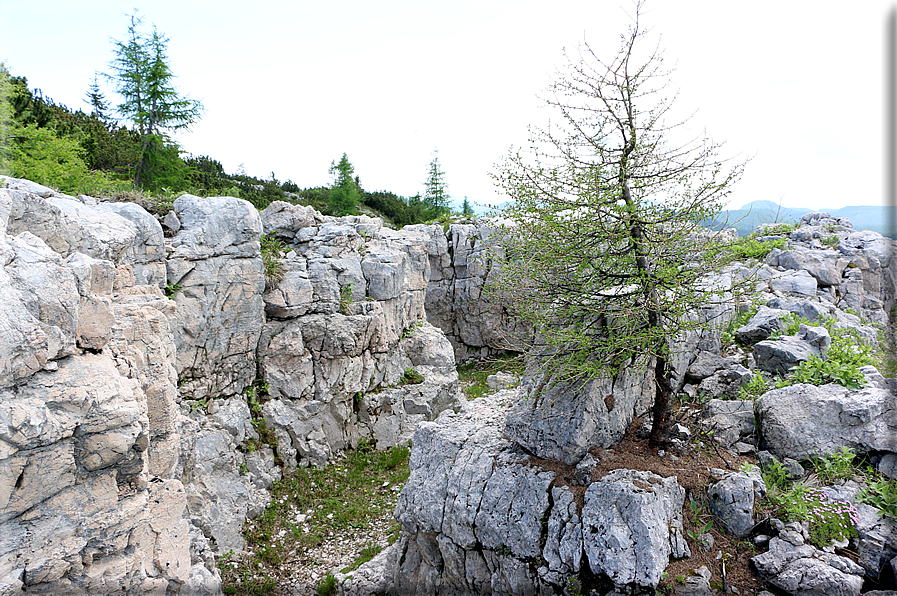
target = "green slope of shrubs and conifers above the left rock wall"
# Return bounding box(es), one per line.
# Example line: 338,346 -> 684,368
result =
0,12 -> 472,226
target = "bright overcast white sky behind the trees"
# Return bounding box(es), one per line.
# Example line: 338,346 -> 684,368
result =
0,0 -> 894,208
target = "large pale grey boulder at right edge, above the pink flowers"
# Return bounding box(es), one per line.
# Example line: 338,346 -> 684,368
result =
756,384 -> 897,459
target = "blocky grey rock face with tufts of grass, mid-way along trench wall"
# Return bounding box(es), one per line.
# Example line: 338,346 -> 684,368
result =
259,204 -> 460,468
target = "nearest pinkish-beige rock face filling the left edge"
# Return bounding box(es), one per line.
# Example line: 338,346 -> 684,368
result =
0,181 -> 200,594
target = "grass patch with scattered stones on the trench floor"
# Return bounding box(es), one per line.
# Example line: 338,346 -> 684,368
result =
221,441 -> 410,594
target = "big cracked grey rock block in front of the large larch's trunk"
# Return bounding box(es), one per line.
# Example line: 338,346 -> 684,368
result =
384,390 -> 690,594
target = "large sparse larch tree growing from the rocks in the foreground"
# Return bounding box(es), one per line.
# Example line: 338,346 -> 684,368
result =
492,1 -> 744,445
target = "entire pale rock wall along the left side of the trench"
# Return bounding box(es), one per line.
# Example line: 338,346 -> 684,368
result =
0,178 -> 459,594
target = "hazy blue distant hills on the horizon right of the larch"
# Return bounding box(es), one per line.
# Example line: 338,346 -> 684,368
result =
710,201 -> 895,238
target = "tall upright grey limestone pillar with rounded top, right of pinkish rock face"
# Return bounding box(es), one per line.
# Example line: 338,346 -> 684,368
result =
167,195 -> 265,399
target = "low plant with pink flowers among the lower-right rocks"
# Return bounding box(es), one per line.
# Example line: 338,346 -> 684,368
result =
778,485 -> 860,548
